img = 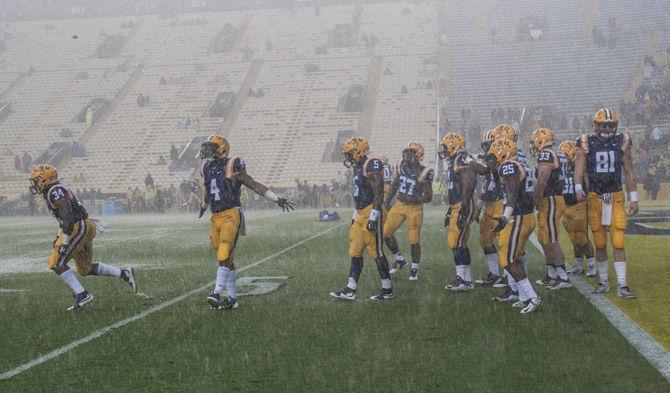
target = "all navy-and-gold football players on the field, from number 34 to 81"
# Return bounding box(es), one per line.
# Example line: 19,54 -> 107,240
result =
29,108 -> 638,314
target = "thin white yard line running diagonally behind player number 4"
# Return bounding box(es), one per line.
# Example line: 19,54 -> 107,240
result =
0,223 -> 344,380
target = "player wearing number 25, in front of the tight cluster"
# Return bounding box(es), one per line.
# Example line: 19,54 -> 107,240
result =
489,138 -> 542,314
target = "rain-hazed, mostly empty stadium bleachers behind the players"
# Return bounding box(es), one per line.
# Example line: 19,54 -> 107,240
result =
0,0 -> 670,210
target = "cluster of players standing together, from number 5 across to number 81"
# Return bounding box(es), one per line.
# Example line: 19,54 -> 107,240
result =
330,108 -> 638,314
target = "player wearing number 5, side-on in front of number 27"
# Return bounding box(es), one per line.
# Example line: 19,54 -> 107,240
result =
330,137 -> 393,300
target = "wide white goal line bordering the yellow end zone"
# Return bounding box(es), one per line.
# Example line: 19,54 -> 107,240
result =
530,234 -> 670,381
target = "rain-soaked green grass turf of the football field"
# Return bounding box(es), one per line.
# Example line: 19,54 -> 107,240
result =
0,209 -> 670,392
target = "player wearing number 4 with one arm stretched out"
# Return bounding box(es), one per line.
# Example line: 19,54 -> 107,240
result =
198,135 -> 294,310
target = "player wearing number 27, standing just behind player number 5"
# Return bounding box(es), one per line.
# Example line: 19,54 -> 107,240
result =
384,142 -> 434,281
